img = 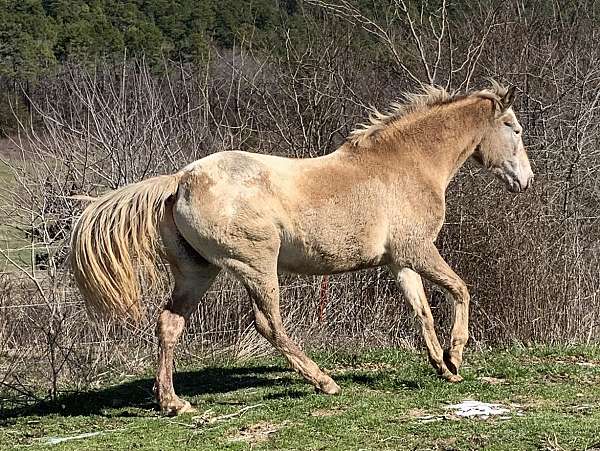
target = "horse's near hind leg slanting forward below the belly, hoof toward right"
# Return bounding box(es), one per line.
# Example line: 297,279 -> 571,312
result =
233,262 -> 340,395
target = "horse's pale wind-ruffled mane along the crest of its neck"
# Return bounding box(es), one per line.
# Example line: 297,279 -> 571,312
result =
348,80 -> 508,146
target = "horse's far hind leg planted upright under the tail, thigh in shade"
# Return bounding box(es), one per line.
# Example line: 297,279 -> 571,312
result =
154,210 -> 220,415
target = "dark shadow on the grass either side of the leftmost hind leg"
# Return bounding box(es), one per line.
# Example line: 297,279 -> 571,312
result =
0,366 -> 292,425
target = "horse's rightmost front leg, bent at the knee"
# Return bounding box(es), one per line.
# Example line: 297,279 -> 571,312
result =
414,243 -> 471,374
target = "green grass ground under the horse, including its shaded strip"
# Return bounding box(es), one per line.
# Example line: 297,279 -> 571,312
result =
0,347 -> 600,450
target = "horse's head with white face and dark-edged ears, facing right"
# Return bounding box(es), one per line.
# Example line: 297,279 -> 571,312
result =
473,87 -> 533,193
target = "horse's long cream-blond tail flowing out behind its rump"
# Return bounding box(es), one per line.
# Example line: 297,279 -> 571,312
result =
71,173 -> 182,320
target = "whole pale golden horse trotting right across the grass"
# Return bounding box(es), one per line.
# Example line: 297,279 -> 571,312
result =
72,83 -> 533,414
